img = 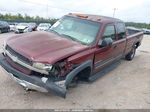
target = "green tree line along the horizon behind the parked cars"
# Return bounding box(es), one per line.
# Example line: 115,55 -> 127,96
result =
0,13 -> 150,29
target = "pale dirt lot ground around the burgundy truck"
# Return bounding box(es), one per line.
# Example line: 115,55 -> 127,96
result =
0,33 -> 150,109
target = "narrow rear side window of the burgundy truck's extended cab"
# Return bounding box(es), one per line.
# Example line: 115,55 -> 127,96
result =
117,23 -> 125,40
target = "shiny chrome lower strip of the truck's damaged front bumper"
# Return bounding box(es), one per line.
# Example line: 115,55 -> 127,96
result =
3,69 -> 48,92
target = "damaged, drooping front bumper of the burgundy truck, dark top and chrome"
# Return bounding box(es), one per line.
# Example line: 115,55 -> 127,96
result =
0,54 -> 67,98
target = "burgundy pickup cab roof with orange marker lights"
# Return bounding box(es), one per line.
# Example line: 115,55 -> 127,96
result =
67,13 -> 123,23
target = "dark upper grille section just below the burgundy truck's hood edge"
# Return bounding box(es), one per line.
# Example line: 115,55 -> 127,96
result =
6,45 -> 32,65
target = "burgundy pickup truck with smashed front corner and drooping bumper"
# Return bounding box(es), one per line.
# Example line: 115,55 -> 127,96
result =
0,13 -> 143,97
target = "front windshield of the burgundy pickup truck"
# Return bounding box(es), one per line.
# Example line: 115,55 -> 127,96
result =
49,16 -> 101,45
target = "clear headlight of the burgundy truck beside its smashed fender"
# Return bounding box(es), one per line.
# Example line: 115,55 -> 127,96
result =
33,63 -> 53,71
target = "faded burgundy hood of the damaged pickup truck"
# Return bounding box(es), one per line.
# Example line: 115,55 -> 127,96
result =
7,32 -> 88,63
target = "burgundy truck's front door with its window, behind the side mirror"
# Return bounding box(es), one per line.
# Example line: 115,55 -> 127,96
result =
94,24 -> 118,72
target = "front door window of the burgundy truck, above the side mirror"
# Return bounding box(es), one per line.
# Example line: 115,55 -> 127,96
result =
102,25 -> 115,40
